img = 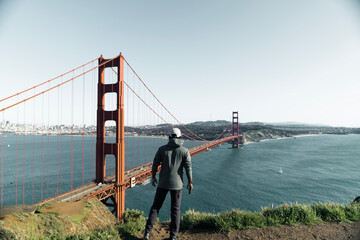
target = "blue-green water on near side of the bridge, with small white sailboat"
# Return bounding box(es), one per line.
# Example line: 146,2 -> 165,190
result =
126,135 -> 360,220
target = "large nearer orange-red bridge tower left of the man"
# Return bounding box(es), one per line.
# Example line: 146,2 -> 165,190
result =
96,54 -> 125,218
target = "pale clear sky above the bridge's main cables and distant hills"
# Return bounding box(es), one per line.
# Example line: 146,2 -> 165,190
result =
0,0 -> 360,127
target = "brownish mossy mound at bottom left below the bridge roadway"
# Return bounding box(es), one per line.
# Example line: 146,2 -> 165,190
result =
0,198 -> 117,239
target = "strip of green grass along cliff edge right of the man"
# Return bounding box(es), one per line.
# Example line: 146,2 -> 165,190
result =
181,203 -> 360,232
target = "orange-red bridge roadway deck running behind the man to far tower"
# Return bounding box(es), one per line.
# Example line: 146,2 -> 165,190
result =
37,135 -> 242,204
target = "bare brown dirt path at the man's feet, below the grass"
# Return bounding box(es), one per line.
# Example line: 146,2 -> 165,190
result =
147,222 -> 360,240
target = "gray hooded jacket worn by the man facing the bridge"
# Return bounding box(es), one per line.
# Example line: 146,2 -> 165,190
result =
152,138 -> 192,190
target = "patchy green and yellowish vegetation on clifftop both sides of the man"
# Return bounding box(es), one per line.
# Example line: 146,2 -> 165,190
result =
0,200 -> 360,240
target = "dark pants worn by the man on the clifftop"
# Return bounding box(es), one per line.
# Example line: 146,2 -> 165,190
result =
145,187 -> 182,237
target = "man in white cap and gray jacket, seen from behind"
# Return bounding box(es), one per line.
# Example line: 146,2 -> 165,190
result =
144,128 -> 193,240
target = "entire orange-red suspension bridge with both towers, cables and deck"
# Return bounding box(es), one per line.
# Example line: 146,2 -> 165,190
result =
0,54 -> 243,218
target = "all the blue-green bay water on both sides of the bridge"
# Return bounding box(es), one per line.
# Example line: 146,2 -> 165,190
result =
2,135 -> 360,220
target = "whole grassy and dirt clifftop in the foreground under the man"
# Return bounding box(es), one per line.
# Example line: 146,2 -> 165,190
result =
0,199 -> 360,240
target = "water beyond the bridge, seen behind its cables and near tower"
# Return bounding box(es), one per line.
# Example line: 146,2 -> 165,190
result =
0,134 -> 195,206
